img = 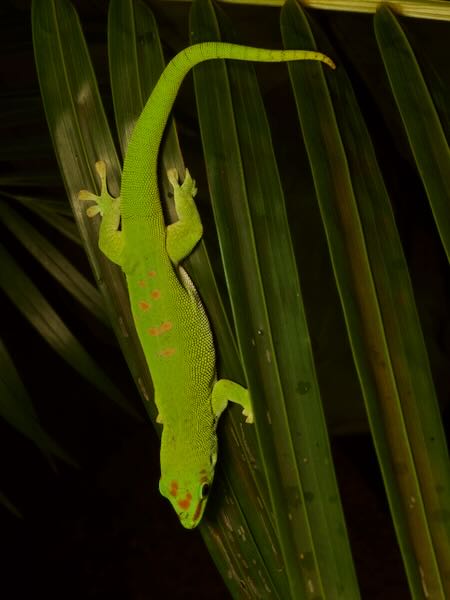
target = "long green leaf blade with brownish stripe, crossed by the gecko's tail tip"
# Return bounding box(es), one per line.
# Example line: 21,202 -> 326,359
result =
282,0 -> 443,598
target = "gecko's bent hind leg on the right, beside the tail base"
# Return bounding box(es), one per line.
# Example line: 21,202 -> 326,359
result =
166,169 -> 203,265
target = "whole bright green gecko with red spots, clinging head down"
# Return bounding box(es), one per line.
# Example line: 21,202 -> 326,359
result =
79,42 -> 335,529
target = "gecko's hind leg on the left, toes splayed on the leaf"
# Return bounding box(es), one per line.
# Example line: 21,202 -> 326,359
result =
78,160 -> 123,265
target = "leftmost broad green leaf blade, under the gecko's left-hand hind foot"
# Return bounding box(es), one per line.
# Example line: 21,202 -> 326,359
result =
32,0 -> 155,417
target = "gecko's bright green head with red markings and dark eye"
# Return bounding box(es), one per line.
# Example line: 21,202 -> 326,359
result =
159,438 -> 217,529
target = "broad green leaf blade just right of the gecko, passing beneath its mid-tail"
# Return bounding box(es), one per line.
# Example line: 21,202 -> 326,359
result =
190,2 -> 359,598
